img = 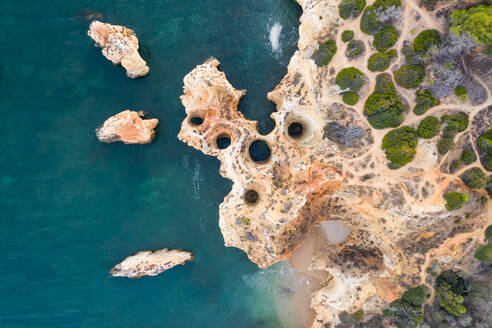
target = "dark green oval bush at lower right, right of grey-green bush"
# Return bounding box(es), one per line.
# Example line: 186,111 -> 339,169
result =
434,271 -> 469,316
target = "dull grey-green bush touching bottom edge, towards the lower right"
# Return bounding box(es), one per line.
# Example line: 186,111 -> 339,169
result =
383,285 -> 430,328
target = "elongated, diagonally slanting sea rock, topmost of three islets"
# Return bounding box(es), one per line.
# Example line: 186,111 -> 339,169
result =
87,21 -> 149,79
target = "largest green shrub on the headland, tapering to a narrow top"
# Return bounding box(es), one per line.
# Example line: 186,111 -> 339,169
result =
364,73 -> 404,129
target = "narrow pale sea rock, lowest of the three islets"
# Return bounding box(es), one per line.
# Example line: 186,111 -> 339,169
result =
110,248 -> 193,278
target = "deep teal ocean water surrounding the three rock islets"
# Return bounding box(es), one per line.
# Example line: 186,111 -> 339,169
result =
0,0 -> 301,328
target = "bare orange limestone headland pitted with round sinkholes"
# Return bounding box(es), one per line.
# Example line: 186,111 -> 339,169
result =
178,0 -> 492,328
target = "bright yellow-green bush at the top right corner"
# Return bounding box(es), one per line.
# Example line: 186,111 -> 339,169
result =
450,5 -> 492,49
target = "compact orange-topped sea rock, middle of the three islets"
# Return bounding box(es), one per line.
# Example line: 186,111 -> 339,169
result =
96,110 -> 159,144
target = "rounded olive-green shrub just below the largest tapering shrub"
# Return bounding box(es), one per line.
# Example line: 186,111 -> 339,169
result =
381,126 -> 418,169
